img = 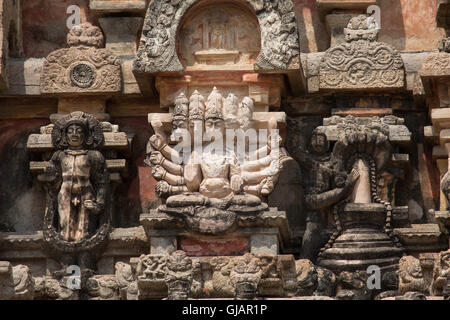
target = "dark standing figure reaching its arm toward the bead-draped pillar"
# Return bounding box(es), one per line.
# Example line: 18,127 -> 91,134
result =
295,132 -> 359,262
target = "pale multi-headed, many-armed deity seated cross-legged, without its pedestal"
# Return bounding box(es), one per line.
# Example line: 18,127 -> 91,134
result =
147,88 -> 285,234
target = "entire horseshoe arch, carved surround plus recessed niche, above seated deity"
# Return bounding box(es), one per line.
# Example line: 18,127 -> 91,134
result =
133,0 -> 304,92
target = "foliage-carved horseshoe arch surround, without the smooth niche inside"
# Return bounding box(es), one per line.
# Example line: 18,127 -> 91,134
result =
133,0 -> 300,73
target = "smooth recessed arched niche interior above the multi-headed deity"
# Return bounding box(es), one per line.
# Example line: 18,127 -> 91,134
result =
177,1 -> 261,68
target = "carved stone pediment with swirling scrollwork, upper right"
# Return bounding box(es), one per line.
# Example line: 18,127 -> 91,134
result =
320,16 -> 405,89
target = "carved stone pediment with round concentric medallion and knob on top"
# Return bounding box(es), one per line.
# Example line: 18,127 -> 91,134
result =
41,23 -> 122,95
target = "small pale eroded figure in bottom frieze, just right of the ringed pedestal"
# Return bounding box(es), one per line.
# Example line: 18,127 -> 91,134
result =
398,256 -> 428,295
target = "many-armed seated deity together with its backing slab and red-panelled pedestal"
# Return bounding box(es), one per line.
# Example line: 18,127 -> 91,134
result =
141,88 -> 293,256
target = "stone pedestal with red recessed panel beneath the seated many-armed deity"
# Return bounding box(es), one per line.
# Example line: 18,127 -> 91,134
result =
140,206 -> 292,256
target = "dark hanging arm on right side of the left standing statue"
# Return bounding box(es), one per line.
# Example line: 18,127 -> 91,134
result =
89,151 -> 109,211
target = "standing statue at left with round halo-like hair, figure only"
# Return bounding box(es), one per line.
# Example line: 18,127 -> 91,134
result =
41,112 -> 109,242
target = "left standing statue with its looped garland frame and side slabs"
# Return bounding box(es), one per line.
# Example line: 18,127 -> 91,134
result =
27,112 -> 129,274
